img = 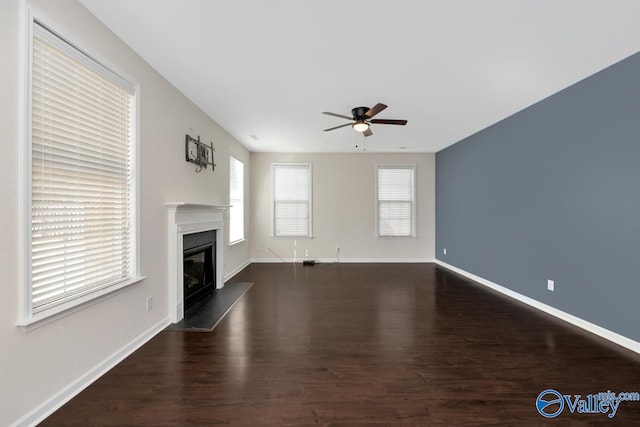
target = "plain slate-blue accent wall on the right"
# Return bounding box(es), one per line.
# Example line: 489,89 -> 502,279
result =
436,54 -> 640,341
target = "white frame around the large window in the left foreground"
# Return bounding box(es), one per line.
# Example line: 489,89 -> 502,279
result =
17,3 -> 145,331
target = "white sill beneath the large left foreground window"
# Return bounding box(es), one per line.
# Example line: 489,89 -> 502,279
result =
16,276 -> 146,332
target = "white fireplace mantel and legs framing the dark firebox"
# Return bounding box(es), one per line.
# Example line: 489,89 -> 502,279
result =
165,202 -> 229,323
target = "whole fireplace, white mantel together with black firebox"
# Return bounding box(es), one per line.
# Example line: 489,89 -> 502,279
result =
165,202 -> 228,323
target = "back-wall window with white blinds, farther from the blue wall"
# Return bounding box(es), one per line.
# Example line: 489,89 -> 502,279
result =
273,163 -> 311,237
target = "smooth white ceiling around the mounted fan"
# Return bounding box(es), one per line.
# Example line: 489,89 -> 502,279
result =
80,0 -> 640,152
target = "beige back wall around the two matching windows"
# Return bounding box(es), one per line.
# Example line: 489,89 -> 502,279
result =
251,153 -> 435,262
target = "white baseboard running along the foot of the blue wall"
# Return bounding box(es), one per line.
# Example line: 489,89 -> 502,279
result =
435,259 -> 640,354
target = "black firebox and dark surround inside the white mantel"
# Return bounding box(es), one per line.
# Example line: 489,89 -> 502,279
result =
182,230 -> 216,310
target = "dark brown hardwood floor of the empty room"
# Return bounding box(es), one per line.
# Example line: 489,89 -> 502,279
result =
43,264 -> 640,426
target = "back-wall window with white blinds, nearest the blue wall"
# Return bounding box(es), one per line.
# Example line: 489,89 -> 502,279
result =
376,165 -> 415,237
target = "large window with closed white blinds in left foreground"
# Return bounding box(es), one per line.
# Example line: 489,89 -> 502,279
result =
22,21 -> 138,324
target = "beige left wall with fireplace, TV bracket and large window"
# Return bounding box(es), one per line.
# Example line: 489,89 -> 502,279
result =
0,0 -> 250,425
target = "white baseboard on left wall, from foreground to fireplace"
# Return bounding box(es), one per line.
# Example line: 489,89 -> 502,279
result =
10,318 -> 170,427
